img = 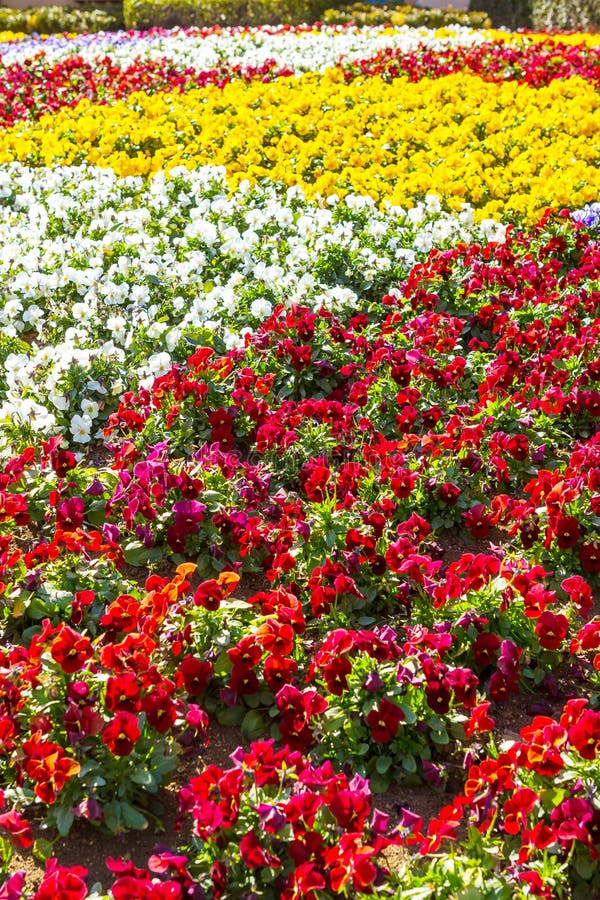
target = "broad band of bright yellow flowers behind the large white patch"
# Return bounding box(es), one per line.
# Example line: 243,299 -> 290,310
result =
0,70 -> 600,220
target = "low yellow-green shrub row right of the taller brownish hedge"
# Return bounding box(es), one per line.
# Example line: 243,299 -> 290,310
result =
323,3 -> 490,28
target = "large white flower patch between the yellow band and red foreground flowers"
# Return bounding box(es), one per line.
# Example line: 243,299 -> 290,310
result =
0,163 -> 504,444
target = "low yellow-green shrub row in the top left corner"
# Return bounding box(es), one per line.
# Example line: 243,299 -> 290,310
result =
0,6 -> 123,34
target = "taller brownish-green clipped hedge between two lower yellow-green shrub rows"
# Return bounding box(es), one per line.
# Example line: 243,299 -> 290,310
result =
123,0 -> 331,28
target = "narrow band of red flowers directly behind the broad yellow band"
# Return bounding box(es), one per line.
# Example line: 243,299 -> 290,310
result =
5,38 -> 600,126
